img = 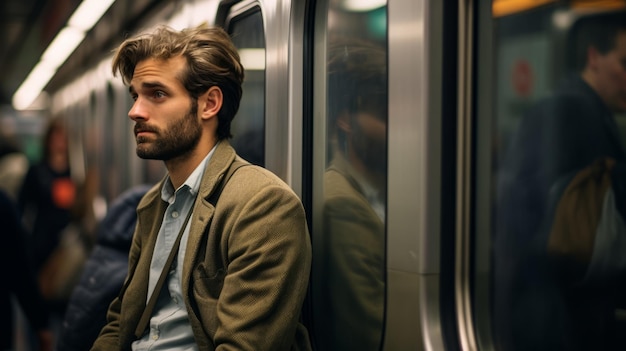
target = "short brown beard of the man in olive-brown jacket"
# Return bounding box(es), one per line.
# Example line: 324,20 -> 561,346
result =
135,99 -> 202,161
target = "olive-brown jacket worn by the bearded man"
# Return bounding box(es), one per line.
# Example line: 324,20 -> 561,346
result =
92,141 -> 311,351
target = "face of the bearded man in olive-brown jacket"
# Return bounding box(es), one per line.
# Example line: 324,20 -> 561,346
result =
128,56 -> 202,161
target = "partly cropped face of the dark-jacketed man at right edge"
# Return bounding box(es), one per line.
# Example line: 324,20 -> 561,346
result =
594,31 -> 626,113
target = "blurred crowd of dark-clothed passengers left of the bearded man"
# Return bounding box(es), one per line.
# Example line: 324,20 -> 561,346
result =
0,118 -> 148,351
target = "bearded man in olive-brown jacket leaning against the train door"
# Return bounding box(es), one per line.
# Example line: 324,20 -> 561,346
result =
92,26 -> 311,350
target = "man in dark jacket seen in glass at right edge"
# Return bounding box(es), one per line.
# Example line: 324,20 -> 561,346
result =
494,11 -> 626,350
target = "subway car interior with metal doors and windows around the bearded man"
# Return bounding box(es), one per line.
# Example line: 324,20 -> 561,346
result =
0,0 -> 626,351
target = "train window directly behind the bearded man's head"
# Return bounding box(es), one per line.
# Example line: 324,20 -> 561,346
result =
228,6 -> 265,166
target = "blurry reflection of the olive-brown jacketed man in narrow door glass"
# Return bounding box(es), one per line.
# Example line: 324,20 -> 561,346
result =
316,40 -> 387,350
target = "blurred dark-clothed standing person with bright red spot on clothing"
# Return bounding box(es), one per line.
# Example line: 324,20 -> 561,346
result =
18,117 -> 93,340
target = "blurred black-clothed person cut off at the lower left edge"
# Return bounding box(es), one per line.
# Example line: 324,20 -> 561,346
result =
0,190 -> 53,351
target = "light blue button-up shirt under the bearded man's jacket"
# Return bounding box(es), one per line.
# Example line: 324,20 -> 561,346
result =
132,147 -> 215,351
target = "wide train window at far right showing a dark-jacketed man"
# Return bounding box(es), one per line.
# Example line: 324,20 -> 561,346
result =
472,1 -> 626,350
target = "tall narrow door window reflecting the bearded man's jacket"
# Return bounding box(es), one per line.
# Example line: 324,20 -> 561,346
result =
311,1 -> 388,350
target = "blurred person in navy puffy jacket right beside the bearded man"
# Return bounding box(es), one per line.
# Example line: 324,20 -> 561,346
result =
57,185 -> 150,351
